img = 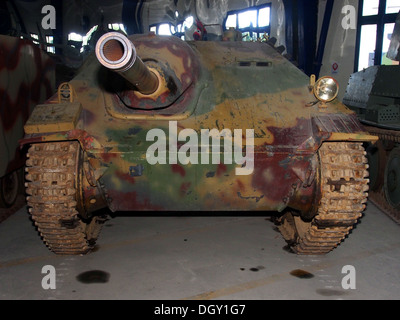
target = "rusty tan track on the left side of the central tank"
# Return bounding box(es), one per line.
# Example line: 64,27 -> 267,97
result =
26,141 -> 102,255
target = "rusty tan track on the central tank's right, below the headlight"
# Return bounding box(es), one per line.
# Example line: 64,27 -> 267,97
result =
278,142 -> 369,255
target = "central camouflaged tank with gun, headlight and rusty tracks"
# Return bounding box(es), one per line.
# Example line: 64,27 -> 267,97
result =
23,33 -> 377,254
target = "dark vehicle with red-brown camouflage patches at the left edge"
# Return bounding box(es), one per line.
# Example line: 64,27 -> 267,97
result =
0,35 -> 55,207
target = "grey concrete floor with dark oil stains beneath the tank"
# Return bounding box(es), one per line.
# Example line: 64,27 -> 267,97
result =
0,204 -> 400,300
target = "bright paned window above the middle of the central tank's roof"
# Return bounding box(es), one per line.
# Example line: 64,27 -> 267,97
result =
224,4 -> 271,41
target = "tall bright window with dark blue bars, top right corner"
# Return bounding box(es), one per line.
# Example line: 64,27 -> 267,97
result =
355,0 -> 400,71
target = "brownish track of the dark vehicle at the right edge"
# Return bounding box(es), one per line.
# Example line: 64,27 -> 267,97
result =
364,125 -> 400,224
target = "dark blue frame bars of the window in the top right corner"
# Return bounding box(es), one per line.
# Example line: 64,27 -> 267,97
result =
354,0 -> 398,72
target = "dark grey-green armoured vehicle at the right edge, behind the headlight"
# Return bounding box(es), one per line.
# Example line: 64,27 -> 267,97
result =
343,15 -> 400,223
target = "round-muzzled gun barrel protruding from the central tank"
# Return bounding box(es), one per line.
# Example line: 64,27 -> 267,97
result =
96,32 -> 159,95
